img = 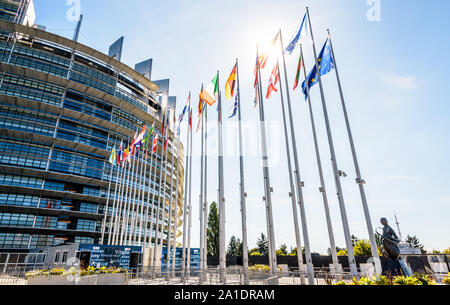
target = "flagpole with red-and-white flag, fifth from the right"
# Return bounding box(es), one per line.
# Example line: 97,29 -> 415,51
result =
277,59 -> 311,285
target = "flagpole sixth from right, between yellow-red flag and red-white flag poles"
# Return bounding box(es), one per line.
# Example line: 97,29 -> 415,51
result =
256,45 -> 277,276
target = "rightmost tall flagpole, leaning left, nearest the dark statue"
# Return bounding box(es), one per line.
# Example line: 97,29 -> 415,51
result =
327,30 -> 383,275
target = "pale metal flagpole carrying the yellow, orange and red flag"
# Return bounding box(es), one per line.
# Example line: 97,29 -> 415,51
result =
236,59 -> 249,285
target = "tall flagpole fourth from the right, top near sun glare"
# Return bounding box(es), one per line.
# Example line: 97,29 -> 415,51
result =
280,30 -> 314,285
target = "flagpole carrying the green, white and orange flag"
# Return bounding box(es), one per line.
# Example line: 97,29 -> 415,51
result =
217,71 -> 227,284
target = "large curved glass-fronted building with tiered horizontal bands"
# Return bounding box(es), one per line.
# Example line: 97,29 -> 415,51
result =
0,10 -> 184,252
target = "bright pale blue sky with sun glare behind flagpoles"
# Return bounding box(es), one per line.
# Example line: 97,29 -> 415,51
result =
35,0 -> 450,253
